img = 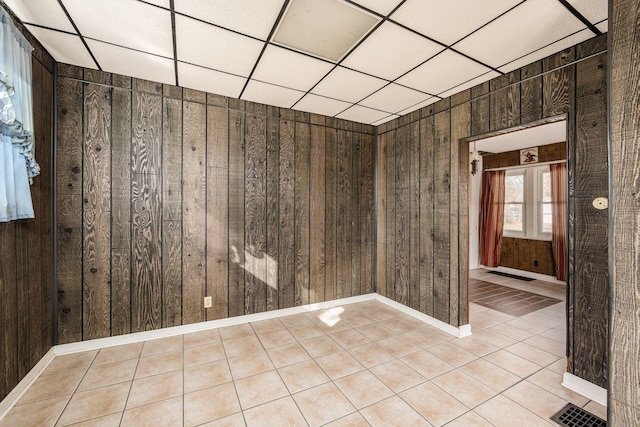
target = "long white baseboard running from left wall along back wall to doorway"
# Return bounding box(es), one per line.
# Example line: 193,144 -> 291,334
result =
0,293 -> 471,421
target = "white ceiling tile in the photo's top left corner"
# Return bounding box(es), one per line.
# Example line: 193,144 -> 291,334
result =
5,0 -> 76,33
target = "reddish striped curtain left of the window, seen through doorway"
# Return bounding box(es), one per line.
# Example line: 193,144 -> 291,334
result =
480,170 -> 505,267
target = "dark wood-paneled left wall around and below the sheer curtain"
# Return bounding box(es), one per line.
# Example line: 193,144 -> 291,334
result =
0,3 -> 54,400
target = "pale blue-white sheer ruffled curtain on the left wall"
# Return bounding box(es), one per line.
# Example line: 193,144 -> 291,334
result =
0,7 -> 40,222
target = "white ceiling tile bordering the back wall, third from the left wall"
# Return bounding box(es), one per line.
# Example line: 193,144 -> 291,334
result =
178,62 -> 247,98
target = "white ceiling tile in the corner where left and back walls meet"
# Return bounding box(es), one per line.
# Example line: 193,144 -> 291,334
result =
27,25 -> 97,69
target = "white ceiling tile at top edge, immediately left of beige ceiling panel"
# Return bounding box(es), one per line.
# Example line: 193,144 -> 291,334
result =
175,0 -> 283,40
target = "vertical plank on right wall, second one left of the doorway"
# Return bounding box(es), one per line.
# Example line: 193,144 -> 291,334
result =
433,110 -> 451,323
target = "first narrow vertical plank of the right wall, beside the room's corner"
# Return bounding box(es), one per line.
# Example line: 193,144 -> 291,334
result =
376,133 -> 387,295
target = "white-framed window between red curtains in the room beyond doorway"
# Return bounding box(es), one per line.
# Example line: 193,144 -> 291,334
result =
503,165 -> 552,240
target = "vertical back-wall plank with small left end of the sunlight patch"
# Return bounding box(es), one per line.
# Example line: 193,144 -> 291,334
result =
229,110 -> 245,316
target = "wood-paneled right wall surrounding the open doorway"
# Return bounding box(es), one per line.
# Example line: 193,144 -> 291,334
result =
376,35 -> 608,387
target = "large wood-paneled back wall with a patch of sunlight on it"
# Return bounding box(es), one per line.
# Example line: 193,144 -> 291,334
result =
56,64 -> 375,343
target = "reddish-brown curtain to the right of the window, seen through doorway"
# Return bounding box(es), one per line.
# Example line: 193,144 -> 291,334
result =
549,163 -> 567,282
